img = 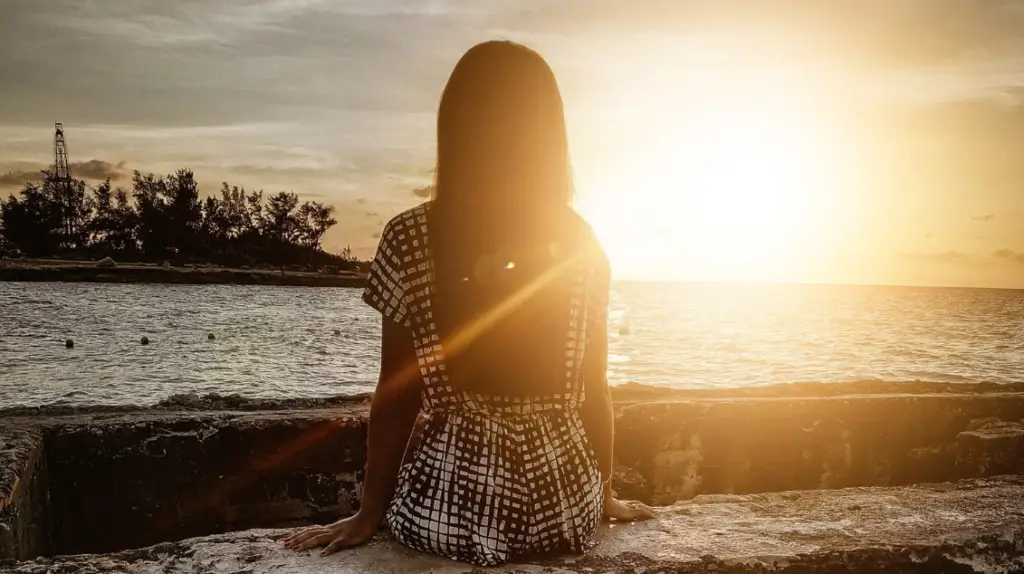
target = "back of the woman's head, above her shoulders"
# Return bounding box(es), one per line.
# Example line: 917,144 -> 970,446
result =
434,41 -> 572,211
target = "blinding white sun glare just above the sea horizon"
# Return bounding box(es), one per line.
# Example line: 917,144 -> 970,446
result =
581,101 -> 827,280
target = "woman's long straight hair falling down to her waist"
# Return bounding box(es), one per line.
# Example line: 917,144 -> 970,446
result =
428,42 -> 585,396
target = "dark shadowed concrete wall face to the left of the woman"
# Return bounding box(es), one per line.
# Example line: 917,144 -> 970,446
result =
46,410 -> 366,553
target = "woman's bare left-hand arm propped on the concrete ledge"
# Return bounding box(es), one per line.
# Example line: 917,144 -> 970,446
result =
285,317 -> 423,554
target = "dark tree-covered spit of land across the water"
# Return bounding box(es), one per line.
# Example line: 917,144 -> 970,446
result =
0,166 -> 366,280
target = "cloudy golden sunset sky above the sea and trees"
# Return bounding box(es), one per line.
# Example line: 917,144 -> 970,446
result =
0,0 -> 1024,288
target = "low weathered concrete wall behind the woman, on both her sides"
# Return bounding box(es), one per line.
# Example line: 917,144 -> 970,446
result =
0,384 -> 1024,558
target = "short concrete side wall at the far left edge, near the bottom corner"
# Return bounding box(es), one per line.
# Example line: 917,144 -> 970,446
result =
0,429 -> 50,560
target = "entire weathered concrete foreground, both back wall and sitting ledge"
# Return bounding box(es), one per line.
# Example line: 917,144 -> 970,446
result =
0,383 -> 1024,574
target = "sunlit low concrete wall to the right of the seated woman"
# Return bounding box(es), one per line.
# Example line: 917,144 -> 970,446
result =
615,393 -> 1024,504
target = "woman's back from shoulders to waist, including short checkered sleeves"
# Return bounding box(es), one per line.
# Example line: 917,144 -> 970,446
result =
366,202 -> 609,411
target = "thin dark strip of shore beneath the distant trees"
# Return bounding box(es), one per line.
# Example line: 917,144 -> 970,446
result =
0,260 -> 366,288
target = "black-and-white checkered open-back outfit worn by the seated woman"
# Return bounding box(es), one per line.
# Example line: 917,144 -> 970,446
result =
362,203 -> 608,566
